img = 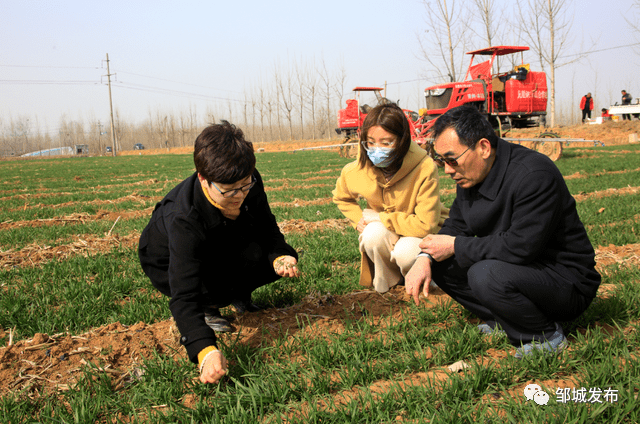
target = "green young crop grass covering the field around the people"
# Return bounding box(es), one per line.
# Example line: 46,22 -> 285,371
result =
0,146 -> 640,423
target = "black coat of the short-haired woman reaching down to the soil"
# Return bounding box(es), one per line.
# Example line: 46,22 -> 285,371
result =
138,170 -> 297,362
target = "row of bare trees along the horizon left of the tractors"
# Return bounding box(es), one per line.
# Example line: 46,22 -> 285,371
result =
0,56 -> 347,156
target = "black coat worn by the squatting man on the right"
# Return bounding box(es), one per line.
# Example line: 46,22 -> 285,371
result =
440,139 -> 601,298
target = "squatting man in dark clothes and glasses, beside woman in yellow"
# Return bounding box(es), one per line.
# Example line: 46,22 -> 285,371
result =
405,106 -> 600,358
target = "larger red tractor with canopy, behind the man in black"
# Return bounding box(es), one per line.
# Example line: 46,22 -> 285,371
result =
421,46 -> 547,136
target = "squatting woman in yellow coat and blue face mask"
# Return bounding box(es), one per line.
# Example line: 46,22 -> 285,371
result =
333,104 -> 449,293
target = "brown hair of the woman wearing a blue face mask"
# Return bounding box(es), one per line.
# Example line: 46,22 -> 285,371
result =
358,102 -> 411,172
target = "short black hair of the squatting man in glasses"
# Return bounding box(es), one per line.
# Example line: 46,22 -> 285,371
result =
432,106 -> 498,148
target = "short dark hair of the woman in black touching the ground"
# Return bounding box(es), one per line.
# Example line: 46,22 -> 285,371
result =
193,121 -> 256,184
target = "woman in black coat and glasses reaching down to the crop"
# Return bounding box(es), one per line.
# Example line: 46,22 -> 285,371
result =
138,121 -> 299,383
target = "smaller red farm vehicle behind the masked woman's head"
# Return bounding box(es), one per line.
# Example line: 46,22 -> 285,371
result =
336,87 -> 426,156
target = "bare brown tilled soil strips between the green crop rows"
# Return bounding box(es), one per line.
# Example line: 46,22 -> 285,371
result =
0,125 -> 640,404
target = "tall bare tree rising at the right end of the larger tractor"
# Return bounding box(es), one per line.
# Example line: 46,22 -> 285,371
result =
517,0 -> 584,128
